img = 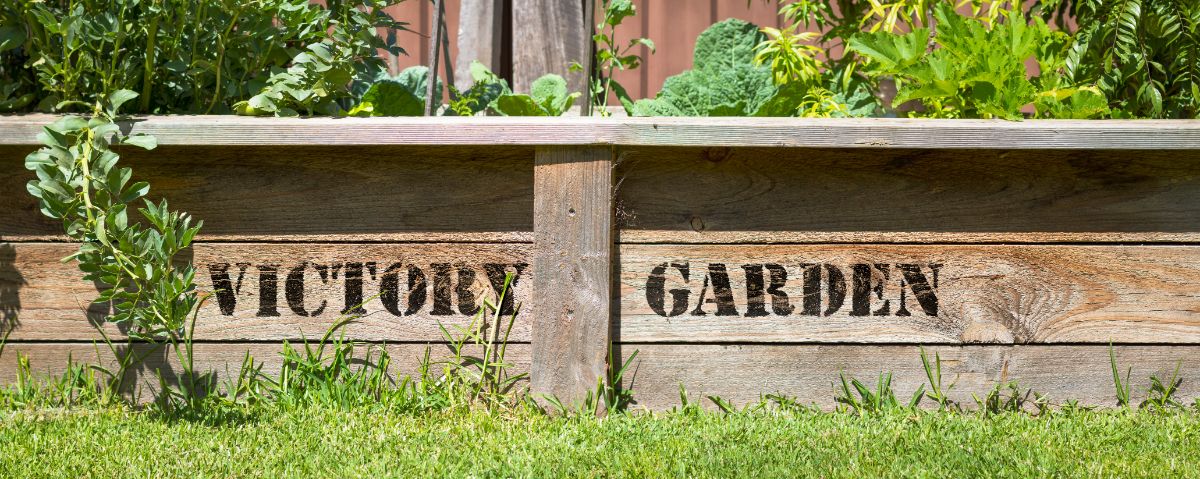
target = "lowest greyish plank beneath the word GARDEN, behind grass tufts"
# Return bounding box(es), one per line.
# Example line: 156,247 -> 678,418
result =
620,345 -> 1200,409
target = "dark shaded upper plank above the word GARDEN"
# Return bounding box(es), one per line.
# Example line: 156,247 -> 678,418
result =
617,148 -> 1200,243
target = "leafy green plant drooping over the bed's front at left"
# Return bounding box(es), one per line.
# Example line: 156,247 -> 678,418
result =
25,90 -> 203,341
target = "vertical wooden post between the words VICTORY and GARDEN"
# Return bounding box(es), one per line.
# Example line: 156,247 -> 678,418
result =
530,146 -> 613,405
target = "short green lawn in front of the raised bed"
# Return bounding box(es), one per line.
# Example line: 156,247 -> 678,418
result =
0,407 -> 1200,478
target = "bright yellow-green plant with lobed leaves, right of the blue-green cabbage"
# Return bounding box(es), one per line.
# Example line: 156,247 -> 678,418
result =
848,4 -> 1108,120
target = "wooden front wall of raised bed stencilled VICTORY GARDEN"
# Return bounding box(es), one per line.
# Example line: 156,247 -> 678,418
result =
0,115 -> 1200,408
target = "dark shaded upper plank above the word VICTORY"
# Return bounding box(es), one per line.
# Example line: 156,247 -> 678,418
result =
0,146 -> 533,241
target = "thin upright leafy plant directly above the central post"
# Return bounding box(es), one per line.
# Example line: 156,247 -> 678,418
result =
572,0 -> 654,116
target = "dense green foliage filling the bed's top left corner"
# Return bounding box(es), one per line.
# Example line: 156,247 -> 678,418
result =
0,0 -> 404,114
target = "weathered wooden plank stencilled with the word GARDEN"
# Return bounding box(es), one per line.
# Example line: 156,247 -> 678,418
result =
619,245 -> 1200,343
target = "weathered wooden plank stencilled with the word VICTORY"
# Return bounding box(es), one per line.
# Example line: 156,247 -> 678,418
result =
0,243 -> 534,342
